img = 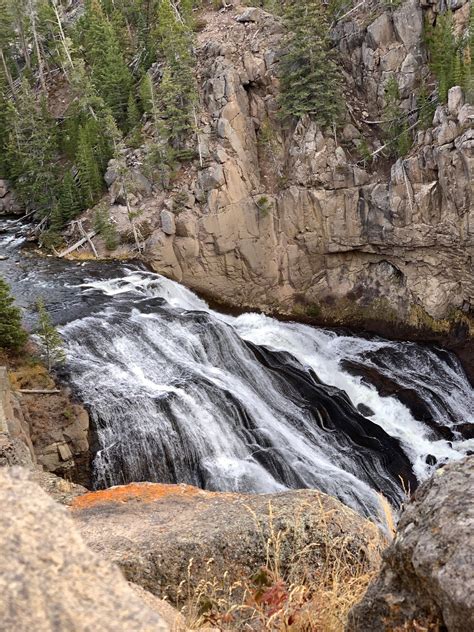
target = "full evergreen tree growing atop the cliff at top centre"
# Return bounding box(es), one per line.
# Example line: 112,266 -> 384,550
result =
280,0 -> 343,126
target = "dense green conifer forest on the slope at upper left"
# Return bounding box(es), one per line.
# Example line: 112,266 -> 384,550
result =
0,0 -> 197,244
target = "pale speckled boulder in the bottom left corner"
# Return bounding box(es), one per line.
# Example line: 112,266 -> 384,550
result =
0,469 -> 172,632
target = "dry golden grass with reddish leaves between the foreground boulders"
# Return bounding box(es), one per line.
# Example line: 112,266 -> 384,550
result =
178,498 -> 394,632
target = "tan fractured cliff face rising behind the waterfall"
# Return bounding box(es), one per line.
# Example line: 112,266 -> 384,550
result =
98,0 -> 474,324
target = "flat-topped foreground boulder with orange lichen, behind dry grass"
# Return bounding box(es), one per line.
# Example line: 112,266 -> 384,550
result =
71,483 -> 386,601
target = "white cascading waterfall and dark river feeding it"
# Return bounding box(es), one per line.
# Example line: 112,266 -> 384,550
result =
0,220 -> 474,516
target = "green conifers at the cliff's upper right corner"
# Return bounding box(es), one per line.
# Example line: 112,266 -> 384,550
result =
425,3 -> 474,103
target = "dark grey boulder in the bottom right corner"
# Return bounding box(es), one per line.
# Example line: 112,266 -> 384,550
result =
347,456 -> 474,632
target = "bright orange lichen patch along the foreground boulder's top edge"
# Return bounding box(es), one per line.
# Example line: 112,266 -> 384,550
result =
71,483 -> 230,509
